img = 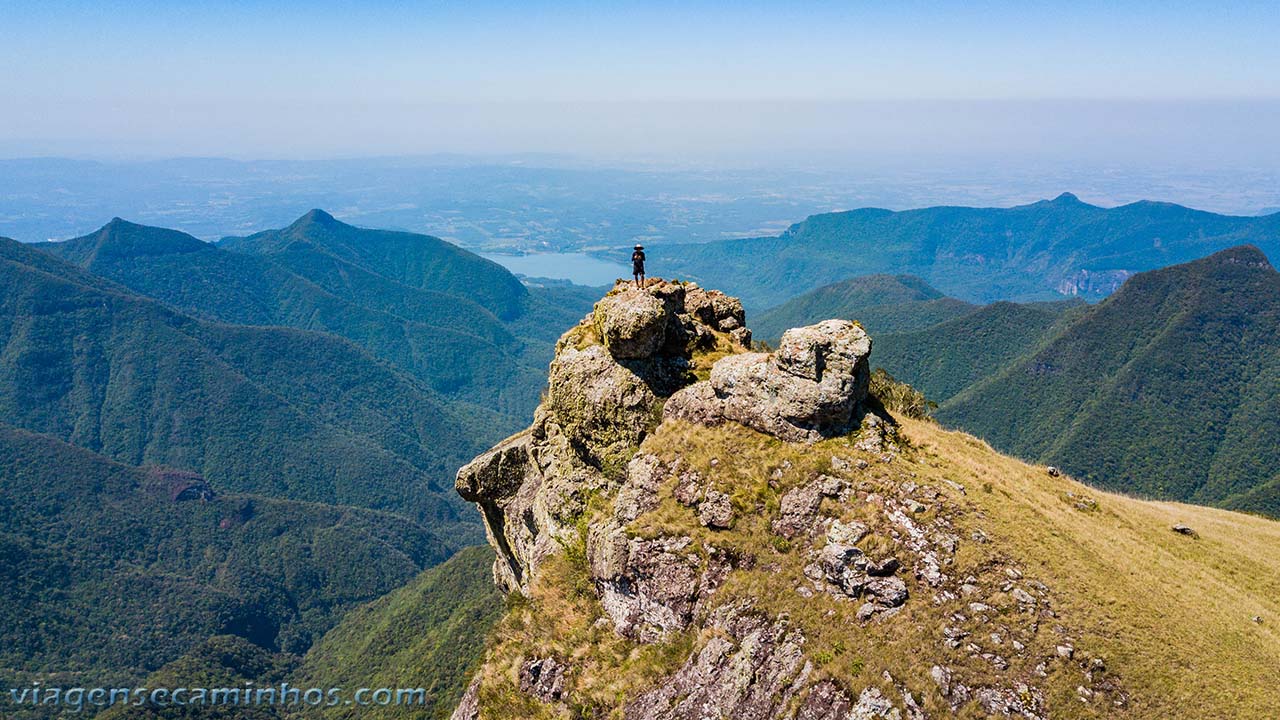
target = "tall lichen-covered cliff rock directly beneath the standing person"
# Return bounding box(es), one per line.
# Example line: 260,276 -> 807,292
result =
456,281 -> 750,592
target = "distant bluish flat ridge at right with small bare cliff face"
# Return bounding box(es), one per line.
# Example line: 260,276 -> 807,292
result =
655,193 -> 1280,309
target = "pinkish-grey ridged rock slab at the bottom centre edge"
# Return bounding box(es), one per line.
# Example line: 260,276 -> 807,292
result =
623,607 -> 814,720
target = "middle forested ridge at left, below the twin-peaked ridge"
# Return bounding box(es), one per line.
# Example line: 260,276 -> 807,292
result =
0,240 -> 481,524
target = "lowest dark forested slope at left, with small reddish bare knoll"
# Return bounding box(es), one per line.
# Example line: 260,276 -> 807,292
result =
0,424 -> 456,691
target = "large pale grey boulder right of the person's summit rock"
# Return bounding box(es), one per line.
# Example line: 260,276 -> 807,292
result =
664,320 -> 870,442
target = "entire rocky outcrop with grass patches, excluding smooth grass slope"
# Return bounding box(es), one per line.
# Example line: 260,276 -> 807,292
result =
454,281 -> 1115,720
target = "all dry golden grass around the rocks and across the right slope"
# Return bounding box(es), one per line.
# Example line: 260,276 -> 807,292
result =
471,409 -> 1280,719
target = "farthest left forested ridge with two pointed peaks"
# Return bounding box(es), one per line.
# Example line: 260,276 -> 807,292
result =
37,210 -> 590,417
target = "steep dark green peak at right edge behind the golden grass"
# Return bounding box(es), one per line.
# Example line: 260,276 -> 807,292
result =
938,246 -> 1280,514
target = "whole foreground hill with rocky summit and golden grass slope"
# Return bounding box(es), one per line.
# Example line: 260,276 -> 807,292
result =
453,283 -> 1280,720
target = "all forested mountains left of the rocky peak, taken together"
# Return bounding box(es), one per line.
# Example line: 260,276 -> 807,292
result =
0,211 -> 593,711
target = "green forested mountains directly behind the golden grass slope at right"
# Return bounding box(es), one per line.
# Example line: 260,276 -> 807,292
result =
762,246 -> 1280,516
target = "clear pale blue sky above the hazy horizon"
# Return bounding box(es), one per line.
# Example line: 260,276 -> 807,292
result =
0,0 -> 1280,164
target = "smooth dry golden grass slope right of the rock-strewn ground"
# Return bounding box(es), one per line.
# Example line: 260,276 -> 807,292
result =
904,420 -> 1280,719
